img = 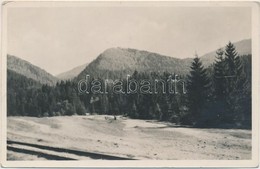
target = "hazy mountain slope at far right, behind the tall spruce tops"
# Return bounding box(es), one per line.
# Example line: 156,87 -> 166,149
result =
201,39 -> 252,66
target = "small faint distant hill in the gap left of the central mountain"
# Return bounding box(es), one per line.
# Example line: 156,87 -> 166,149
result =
56,63 -> 88,80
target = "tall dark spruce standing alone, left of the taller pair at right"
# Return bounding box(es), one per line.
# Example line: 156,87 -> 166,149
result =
187,55 -> 209,122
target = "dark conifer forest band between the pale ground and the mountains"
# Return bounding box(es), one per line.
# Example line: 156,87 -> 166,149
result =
7,42 -> 251,128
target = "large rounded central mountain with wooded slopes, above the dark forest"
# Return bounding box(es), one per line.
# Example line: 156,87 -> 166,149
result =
75,48 -> 190,79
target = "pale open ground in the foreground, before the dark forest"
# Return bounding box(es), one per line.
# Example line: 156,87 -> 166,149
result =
7,115 -> 251,160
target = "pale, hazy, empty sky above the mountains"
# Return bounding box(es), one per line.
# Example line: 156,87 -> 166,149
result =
7,4 -> 251,75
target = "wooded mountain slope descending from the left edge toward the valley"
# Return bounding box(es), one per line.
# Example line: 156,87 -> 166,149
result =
7,55 -> 58,85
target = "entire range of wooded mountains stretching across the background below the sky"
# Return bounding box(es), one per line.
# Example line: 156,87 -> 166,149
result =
7,39 -> 251,85
